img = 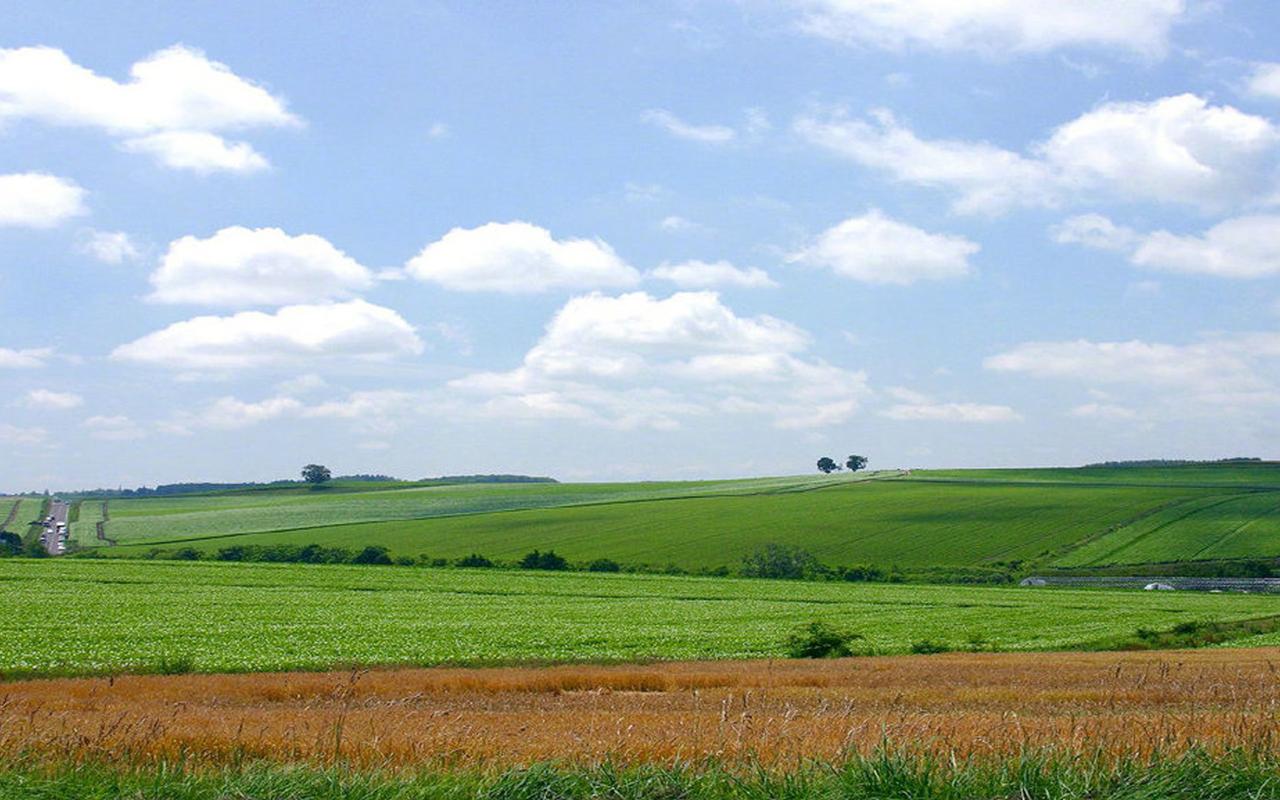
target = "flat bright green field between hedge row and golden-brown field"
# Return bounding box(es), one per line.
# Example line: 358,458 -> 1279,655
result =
0,558 -> 1280,676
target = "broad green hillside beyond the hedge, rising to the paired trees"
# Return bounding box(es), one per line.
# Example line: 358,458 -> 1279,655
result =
93,463 -> 1280,571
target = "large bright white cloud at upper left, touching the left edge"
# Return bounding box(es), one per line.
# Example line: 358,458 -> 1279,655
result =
0,45 -> 300,173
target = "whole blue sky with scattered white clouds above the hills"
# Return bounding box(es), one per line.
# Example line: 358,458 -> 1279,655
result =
0,0 -> 1280,492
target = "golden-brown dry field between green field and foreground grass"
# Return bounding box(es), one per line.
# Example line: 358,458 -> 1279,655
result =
0,649 -> 1280,767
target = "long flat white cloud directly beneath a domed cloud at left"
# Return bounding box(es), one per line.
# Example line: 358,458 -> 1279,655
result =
111,300 -> 422,370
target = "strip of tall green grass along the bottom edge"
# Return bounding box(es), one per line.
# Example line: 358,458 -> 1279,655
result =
0,751 -> 1280,800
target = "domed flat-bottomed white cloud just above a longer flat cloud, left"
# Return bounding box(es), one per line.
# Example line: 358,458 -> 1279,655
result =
150,227 -> 374,306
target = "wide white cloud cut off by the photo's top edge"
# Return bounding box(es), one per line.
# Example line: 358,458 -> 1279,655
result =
796,0 -> 1187,56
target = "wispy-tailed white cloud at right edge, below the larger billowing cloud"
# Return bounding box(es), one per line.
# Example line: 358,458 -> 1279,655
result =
1055,214 -> 1280,279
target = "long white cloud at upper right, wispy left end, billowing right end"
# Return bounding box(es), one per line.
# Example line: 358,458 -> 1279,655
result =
795,95 -> 1280,214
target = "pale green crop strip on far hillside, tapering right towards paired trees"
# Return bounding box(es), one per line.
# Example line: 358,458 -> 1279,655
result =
90,475 -> 850,543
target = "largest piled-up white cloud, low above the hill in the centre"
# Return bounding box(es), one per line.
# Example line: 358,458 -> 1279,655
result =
449,292 -> 868,429
